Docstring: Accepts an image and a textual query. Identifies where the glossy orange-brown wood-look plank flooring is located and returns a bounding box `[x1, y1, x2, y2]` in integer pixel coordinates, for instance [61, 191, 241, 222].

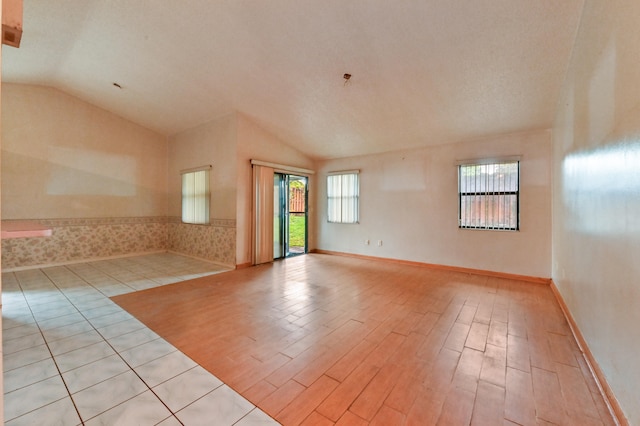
[113, 254, 614, 425]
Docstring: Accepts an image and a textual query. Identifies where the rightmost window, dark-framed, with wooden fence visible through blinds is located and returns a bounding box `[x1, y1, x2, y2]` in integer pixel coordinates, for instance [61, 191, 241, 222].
[458, 161, 520, 231]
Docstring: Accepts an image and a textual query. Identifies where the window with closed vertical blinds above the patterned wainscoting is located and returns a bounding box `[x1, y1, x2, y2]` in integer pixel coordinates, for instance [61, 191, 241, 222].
[182, 166, 211, 224]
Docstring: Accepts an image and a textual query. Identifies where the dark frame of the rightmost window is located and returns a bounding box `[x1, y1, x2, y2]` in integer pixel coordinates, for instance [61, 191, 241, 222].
[457, 157, 521, 232]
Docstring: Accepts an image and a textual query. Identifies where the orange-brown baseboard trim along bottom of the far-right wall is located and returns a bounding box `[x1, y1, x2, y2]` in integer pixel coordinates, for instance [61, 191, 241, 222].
[550, 280, 629, 426]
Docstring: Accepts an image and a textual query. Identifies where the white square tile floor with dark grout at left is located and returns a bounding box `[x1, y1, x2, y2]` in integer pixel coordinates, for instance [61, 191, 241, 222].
[2, 253, 277, 426]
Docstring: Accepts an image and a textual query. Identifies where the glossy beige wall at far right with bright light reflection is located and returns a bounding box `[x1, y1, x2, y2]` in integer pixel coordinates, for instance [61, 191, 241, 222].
[553, 0, 640, 424]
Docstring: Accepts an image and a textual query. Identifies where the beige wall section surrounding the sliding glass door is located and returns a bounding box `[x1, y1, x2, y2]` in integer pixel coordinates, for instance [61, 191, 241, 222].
[236, 114, 315, 265]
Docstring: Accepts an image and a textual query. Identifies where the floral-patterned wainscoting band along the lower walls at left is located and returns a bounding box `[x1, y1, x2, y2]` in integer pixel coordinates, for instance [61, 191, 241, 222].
[2, 220, 236, 270]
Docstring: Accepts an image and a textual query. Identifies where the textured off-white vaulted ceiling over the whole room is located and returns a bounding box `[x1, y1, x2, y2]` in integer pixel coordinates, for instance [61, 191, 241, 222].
[2, 0, 584, 158]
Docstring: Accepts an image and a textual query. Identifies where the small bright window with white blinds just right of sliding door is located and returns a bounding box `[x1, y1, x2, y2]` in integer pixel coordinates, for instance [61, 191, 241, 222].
[327, 171, 360, 223]
